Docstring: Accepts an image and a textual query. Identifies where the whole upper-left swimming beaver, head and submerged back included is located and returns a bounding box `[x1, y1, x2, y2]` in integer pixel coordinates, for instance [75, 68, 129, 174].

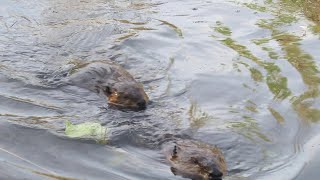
[68, 61, 149, 110]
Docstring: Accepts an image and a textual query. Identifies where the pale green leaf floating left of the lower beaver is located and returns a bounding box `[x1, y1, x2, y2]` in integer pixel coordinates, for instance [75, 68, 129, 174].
[65, 121, 107, 143]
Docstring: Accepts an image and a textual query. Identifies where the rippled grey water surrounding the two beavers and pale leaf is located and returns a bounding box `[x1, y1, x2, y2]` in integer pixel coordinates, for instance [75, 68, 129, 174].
[0, 0, 320, 179]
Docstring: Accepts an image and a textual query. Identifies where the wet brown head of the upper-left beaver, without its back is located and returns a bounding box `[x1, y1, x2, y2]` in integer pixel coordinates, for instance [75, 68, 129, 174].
[104, 81, 149, 109]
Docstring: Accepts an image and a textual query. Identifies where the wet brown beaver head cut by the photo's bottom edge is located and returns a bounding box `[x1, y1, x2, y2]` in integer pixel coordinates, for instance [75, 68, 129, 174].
[165, 140, 227, 180]
